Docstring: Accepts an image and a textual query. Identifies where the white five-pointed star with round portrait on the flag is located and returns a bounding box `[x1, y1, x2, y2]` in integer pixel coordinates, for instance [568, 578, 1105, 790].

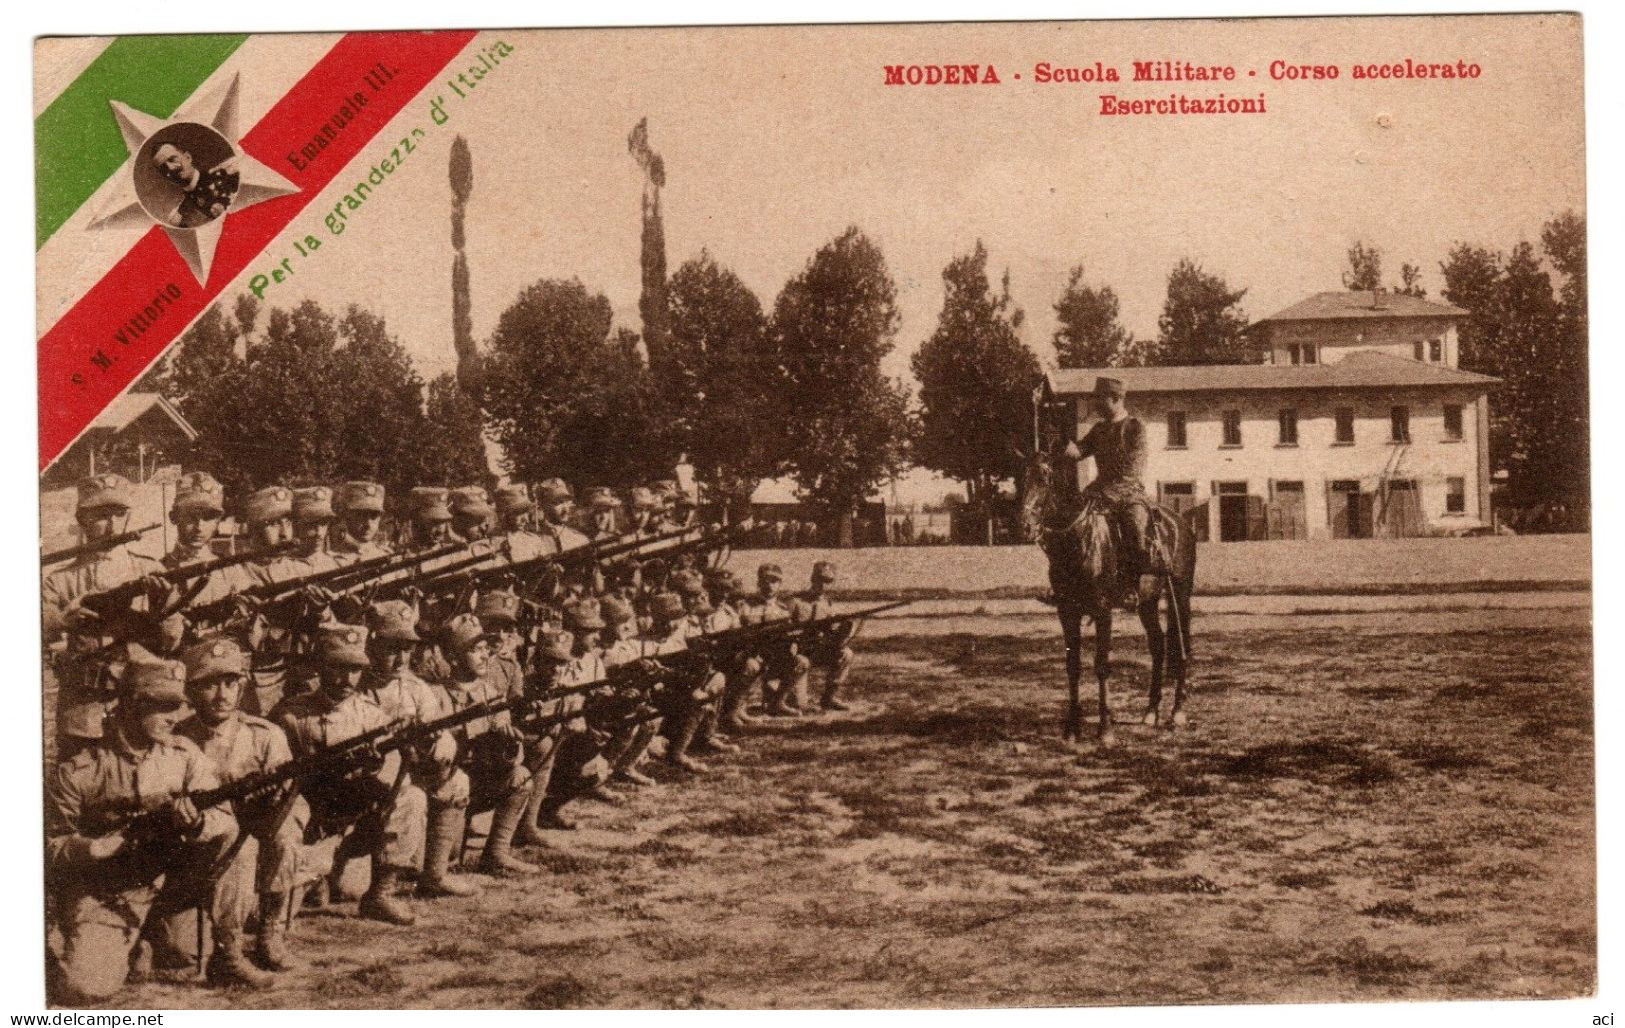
[89, 75, 299, 284]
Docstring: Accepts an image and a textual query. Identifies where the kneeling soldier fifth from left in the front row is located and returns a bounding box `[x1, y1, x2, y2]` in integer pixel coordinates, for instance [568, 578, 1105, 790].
[437, 614, 540, 877]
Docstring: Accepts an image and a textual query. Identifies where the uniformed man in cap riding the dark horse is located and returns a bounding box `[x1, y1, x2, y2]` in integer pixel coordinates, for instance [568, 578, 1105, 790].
[1061, 377, 1152, 578]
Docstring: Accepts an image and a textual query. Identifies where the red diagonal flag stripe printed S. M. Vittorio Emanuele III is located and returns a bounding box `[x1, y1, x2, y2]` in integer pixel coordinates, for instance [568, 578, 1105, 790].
[39, 32, 475, 469]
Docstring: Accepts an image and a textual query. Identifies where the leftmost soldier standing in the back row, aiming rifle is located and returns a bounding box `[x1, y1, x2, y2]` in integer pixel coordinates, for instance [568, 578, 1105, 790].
[41, 474, 164, 757]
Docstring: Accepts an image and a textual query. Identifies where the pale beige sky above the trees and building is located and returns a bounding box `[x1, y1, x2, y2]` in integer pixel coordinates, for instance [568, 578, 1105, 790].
[31, 15, 1584, 500]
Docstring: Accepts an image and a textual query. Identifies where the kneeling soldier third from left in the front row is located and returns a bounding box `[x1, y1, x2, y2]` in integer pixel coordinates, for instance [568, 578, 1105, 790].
[271, 622, 427, 924]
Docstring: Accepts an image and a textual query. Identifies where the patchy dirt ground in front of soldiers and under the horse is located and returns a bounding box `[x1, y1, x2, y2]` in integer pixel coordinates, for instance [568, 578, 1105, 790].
[104, 607, 1596, 1009]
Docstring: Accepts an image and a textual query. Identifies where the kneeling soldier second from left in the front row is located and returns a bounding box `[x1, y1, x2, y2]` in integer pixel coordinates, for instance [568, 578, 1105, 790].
[176, 638, 310, 986]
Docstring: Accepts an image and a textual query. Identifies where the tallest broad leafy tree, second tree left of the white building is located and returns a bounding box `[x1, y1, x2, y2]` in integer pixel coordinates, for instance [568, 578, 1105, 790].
[770, 226, 908, 546]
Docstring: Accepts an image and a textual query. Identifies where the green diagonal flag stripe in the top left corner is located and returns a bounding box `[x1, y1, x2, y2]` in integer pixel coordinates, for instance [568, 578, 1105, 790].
[34, 36, 247, 250]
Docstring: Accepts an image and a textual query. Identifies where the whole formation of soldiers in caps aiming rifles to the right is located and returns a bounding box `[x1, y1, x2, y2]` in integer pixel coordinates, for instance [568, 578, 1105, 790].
[44, 473, 855, 1002]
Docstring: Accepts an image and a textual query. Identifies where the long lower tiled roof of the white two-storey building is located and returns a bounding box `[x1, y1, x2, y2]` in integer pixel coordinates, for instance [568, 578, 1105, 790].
[1045, 349, 1500, 396]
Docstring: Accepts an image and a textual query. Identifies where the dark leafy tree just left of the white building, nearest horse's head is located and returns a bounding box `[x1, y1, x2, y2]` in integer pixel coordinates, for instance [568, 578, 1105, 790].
[912, 239, 1040, 542]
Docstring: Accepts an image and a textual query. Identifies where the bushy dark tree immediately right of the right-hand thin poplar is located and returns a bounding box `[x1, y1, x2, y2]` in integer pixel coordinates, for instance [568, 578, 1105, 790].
[663, 250, 783, 508]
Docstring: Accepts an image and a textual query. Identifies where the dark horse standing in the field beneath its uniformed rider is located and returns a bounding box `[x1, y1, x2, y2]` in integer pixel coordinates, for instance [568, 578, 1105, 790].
[1022, 455, 1196, 747]
